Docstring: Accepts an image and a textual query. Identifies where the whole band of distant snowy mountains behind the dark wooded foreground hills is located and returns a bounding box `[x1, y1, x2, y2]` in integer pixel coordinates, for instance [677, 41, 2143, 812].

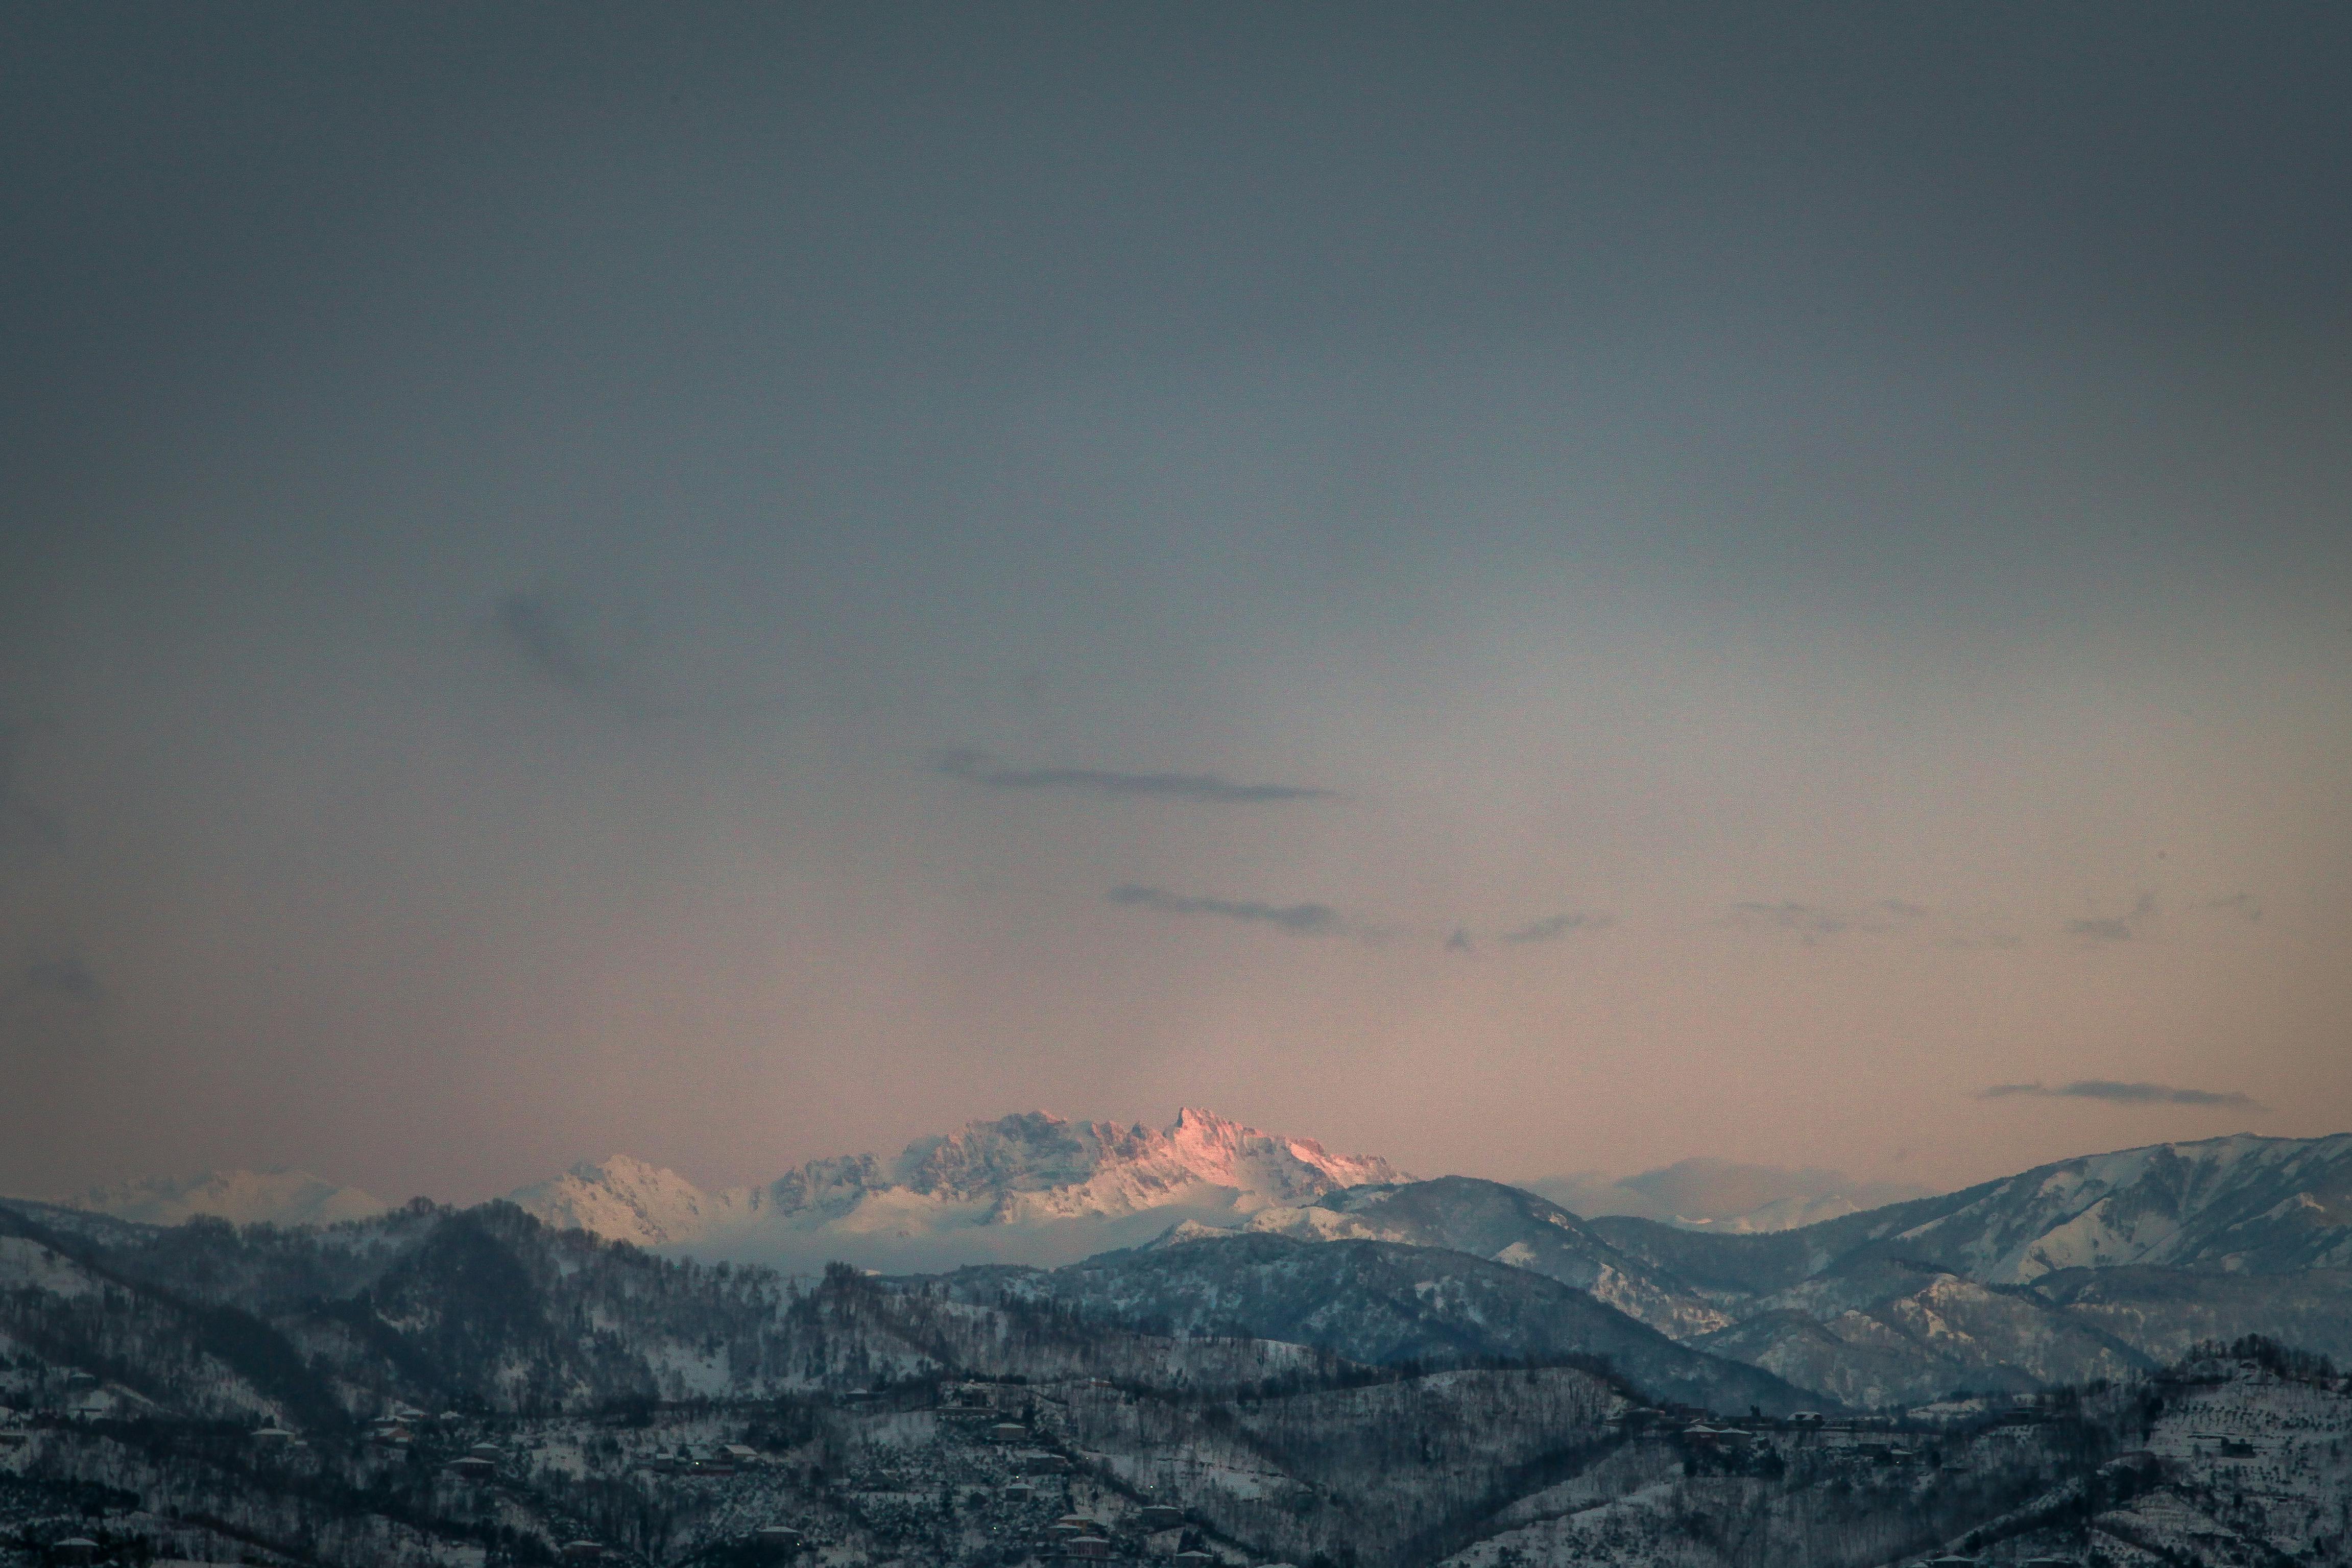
[18, 1109, 2352, 1406]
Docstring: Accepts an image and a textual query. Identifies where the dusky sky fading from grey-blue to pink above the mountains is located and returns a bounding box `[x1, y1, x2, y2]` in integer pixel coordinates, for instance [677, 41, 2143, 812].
[0, 5, 2352, 1201]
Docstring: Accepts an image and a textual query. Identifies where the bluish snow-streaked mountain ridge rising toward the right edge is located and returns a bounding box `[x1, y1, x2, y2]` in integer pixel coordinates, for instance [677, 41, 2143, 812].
[1543, 1136, 2352, 1404]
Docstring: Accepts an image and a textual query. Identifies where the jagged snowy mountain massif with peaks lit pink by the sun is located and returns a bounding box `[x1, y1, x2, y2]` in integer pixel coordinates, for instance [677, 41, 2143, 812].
[513, 1107, 1402, 1269]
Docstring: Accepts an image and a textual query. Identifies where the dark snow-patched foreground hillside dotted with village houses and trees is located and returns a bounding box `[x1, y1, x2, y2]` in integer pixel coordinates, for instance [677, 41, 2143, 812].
[0, 1345, 2352, 1568]
